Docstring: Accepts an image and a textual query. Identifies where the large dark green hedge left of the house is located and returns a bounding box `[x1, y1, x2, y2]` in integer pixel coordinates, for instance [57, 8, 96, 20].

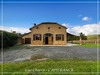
[0, 31, 19, 48]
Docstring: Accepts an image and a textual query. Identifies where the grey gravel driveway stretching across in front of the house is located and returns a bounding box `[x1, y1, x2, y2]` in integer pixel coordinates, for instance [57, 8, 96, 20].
[0, 46, 100, 62]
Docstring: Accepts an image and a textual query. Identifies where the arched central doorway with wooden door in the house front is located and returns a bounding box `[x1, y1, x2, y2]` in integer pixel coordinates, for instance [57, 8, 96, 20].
[43, 33, 53, 45]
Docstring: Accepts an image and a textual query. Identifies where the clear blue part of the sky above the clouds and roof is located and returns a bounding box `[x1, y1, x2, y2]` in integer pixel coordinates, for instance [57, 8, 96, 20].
[3, 3, 97, 28]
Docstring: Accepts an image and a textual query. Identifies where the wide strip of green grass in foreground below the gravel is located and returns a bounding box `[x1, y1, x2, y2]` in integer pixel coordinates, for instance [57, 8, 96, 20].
[0, 59, 100, 75]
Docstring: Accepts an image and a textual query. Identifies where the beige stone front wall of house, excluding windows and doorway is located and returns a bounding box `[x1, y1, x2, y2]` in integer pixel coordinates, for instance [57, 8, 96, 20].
[30, 24, 67, 45]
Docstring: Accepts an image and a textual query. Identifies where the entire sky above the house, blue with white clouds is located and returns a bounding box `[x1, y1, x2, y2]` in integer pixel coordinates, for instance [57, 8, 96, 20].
[0, 0, 100, 35]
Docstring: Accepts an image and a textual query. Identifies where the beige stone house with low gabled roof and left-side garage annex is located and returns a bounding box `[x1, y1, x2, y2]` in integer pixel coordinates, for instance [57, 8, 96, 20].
[22, 22, 67, 45]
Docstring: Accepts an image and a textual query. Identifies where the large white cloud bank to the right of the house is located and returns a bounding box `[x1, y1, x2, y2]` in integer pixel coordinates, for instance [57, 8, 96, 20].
[70, 24, 100, 35]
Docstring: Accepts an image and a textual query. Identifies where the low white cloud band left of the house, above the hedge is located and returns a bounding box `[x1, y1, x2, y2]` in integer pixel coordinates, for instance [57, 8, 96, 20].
[0, 26, 30, 34]
